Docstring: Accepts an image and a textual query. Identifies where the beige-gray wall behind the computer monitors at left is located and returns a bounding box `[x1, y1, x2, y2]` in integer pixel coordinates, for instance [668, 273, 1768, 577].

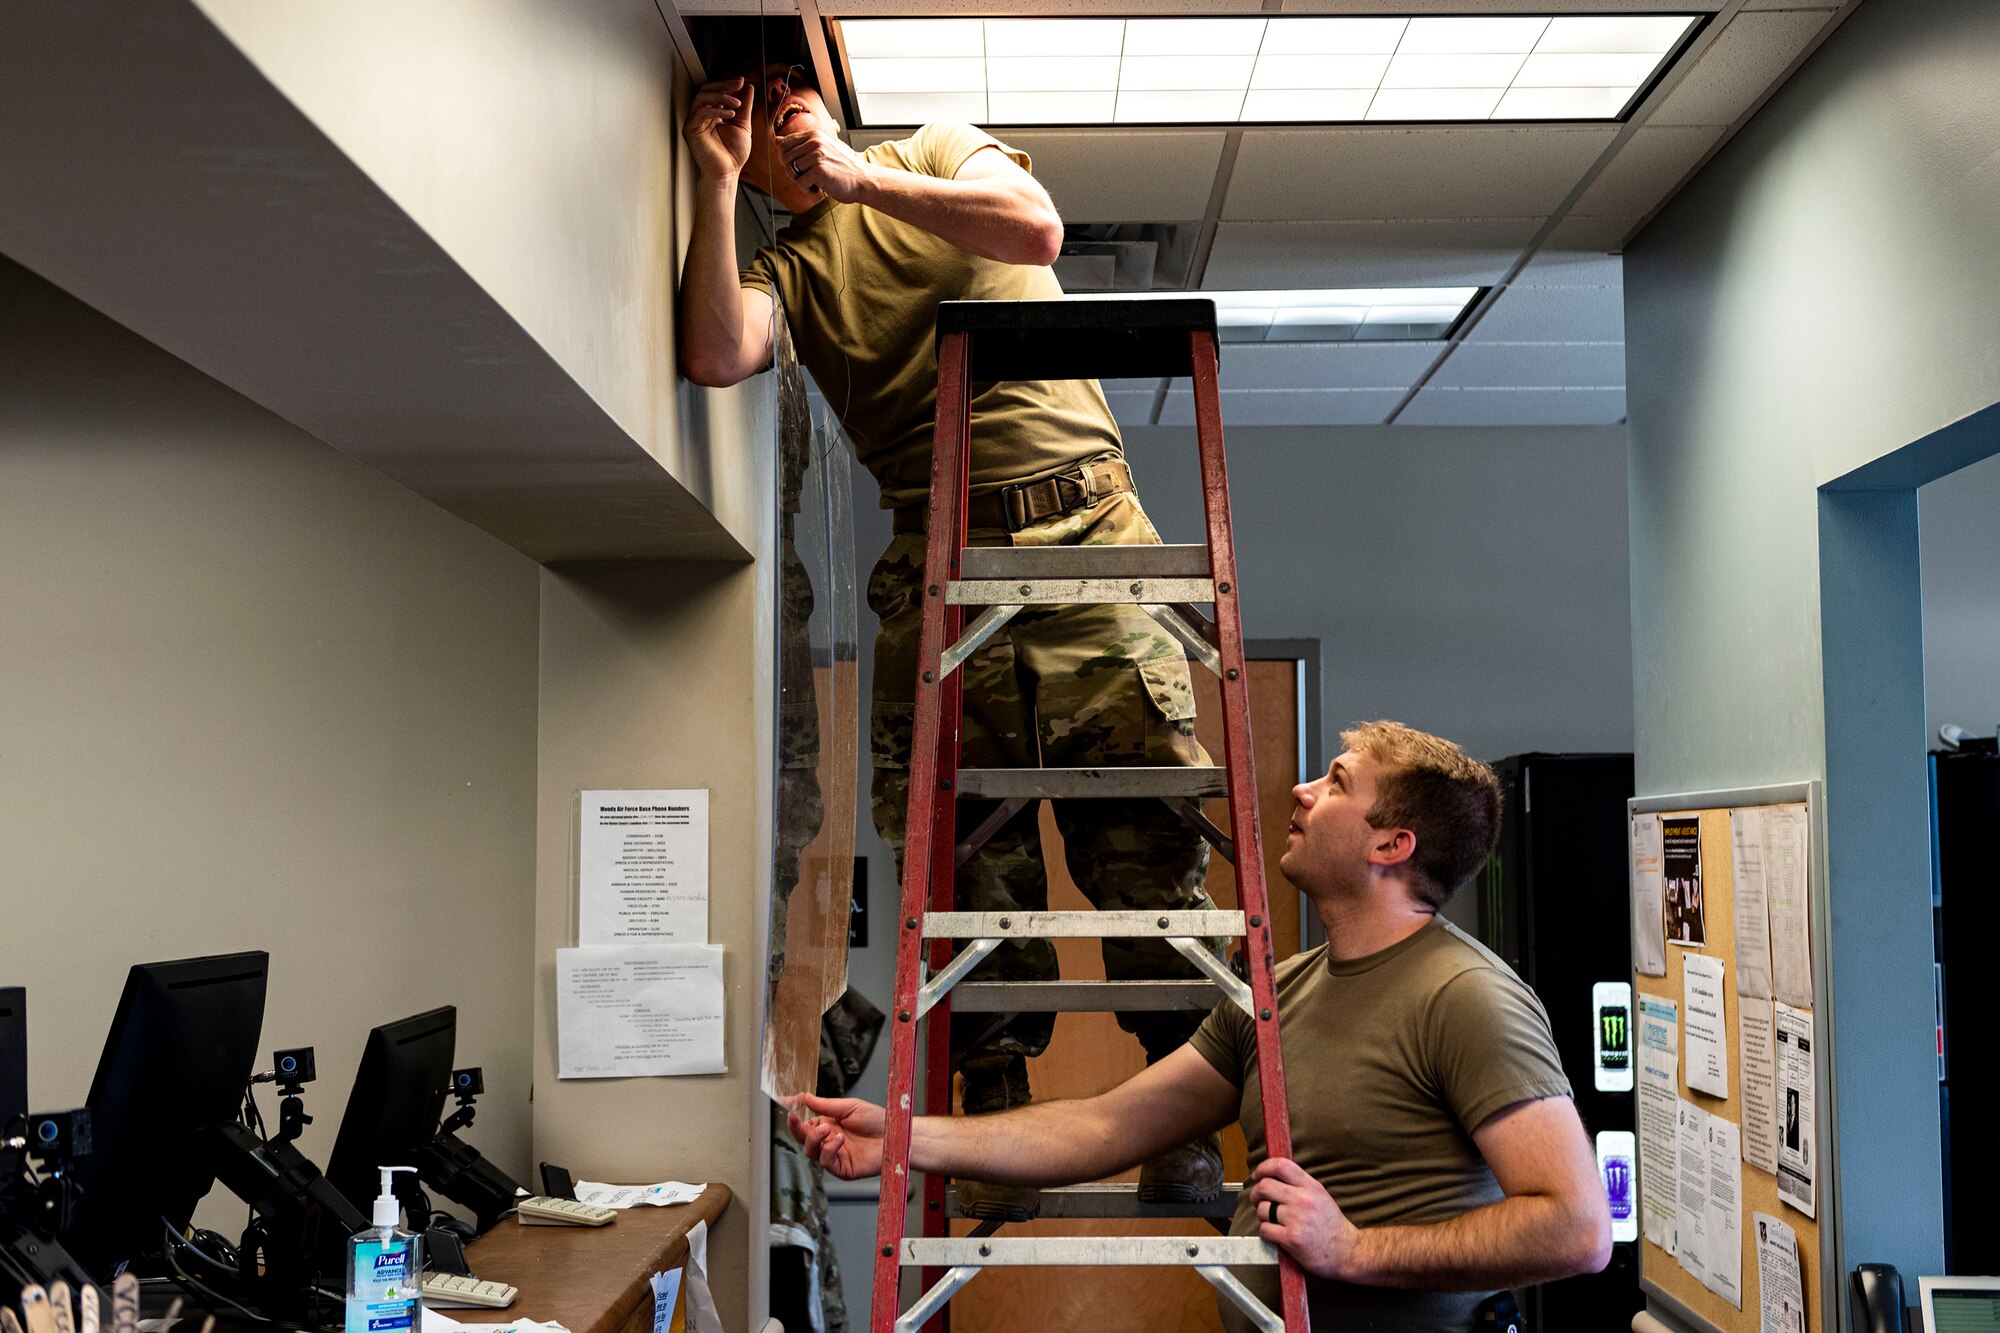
[0, 260, 538, 1208]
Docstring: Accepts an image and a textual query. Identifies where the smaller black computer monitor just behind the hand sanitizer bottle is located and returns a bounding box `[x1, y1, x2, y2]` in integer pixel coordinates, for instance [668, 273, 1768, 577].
[326, 1005, 458, 1223]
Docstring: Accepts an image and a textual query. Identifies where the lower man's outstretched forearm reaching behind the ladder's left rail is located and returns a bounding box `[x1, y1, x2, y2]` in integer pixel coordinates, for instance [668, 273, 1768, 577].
[910, 1099, 1136, 1185]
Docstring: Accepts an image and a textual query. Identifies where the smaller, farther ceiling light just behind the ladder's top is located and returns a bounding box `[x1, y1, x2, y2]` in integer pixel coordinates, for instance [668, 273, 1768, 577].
[1070, 286, 1480, 342]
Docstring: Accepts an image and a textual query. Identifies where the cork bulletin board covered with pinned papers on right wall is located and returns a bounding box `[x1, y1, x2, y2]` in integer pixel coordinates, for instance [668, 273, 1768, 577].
[1630, 783, 1840, 1333]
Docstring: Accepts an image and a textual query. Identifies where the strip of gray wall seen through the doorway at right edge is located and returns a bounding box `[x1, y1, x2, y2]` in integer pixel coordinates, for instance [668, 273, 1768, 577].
[1918, 446, 2000, 747]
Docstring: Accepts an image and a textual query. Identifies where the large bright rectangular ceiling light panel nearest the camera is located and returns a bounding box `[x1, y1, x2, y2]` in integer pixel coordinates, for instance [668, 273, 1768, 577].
[836, 14, 1698, 126]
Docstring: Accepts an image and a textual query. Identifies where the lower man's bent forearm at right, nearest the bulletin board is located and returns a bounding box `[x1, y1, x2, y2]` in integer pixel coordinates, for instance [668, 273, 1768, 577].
[1342, 1195, 1602, 1291]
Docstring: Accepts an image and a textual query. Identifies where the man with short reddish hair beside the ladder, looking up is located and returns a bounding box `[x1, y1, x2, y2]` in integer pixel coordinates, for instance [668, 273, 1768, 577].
[792, 723, 1612, 1333]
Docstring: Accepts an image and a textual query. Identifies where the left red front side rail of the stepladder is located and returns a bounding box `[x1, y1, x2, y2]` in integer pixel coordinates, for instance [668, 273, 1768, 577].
[868, 336, 972, 1333]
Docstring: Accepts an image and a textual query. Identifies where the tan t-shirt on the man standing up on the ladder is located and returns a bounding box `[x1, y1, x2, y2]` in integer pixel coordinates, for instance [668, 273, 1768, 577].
[740, 124, 1120, 508]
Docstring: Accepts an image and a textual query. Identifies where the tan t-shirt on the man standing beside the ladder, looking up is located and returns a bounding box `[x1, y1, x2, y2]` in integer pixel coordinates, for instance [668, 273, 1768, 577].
[1192, 919, 1570, 1333]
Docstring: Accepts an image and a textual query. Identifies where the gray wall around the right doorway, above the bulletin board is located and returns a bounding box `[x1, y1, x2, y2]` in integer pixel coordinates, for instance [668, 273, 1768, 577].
[1626, 0, 2000, 1273]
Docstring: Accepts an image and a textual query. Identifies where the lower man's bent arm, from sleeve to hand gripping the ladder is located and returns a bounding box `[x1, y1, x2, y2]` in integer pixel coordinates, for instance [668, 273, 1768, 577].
[1250, 1097, 1612, 1291]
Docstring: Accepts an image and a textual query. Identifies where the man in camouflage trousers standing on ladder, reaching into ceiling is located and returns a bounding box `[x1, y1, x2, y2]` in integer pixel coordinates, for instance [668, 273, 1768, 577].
[680, 64, 1222, 1221]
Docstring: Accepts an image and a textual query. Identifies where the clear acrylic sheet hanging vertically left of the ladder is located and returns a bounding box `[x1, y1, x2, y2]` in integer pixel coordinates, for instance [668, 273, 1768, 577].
[762, 318, 860, 1097]
